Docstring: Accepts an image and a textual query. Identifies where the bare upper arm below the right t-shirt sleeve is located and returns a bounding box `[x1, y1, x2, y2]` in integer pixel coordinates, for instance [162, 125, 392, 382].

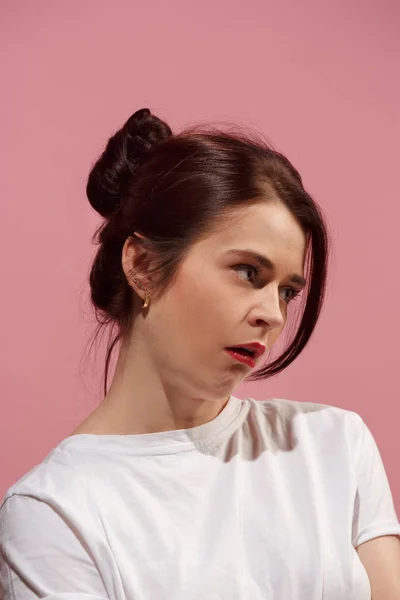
[357, 535, 400, 600]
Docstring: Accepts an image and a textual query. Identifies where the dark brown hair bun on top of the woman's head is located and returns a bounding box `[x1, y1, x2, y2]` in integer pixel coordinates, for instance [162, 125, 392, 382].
[86, 108, 172, 218]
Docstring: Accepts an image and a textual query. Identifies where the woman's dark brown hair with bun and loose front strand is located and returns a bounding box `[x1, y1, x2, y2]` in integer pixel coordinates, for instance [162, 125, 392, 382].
[86, 108, 328, 394]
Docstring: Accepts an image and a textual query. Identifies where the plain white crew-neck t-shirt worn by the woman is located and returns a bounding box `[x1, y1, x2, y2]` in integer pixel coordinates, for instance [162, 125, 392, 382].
[0, 396, 400, 600]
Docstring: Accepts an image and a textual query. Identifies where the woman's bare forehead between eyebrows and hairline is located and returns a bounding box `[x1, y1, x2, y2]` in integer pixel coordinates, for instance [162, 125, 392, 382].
[197, 201, 306, 273]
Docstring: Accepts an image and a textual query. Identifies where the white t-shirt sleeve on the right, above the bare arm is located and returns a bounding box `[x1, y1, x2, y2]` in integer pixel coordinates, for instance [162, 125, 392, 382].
[351, 413, 400, 548]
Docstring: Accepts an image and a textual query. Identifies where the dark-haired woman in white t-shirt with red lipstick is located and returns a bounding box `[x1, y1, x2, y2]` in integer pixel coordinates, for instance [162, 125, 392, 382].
[0, 109, 400, 600]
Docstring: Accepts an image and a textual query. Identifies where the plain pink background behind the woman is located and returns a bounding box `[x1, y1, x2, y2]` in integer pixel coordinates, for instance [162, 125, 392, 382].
[0, 0, 400, 512]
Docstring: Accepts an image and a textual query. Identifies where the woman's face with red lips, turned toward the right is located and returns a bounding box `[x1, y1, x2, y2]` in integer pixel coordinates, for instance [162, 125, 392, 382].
[136, 202, 306, 399]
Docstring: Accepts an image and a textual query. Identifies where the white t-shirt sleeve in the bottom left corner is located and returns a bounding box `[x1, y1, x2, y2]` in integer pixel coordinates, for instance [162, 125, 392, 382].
[0, 495, 108, 600]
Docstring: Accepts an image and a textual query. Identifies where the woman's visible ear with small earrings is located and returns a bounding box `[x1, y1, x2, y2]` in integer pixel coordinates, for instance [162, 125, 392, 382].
[121, 232, 151, 296]
